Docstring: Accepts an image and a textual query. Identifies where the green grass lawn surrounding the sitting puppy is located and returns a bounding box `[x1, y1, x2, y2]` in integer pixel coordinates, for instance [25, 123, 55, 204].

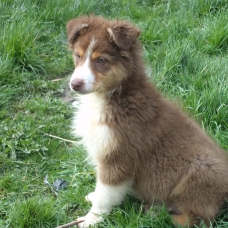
[0, 0, 228, 228]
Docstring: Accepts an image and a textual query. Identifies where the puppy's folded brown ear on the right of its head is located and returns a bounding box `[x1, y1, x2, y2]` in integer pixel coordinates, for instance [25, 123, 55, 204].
[107, 21, 141, 50]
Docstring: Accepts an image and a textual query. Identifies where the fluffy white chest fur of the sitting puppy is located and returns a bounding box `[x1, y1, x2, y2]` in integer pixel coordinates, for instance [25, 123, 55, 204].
[73, 93, 116, 165]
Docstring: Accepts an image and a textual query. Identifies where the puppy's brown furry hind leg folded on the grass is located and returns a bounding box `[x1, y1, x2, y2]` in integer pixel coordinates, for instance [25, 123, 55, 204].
[170, 171, 225, 227]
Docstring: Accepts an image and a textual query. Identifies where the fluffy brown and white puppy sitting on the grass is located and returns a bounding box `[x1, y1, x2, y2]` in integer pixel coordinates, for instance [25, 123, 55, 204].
[67, 15, 228, 227]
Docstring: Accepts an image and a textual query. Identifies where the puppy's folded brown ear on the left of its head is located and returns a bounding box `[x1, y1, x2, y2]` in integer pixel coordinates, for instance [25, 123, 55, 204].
[66, 16, 89, 44]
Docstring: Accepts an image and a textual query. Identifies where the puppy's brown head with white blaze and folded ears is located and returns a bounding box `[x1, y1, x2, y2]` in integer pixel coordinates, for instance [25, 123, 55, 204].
[67, 15, 140, 94]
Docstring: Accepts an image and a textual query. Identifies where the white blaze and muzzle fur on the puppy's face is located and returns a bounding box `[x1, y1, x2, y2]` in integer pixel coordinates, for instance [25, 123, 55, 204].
[70, 38, 96, 93]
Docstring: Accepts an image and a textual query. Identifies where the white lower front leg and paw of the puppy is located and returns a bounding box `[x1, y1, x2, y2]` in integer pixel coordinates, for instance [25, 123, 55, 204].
[78, 180, 131, 228]
